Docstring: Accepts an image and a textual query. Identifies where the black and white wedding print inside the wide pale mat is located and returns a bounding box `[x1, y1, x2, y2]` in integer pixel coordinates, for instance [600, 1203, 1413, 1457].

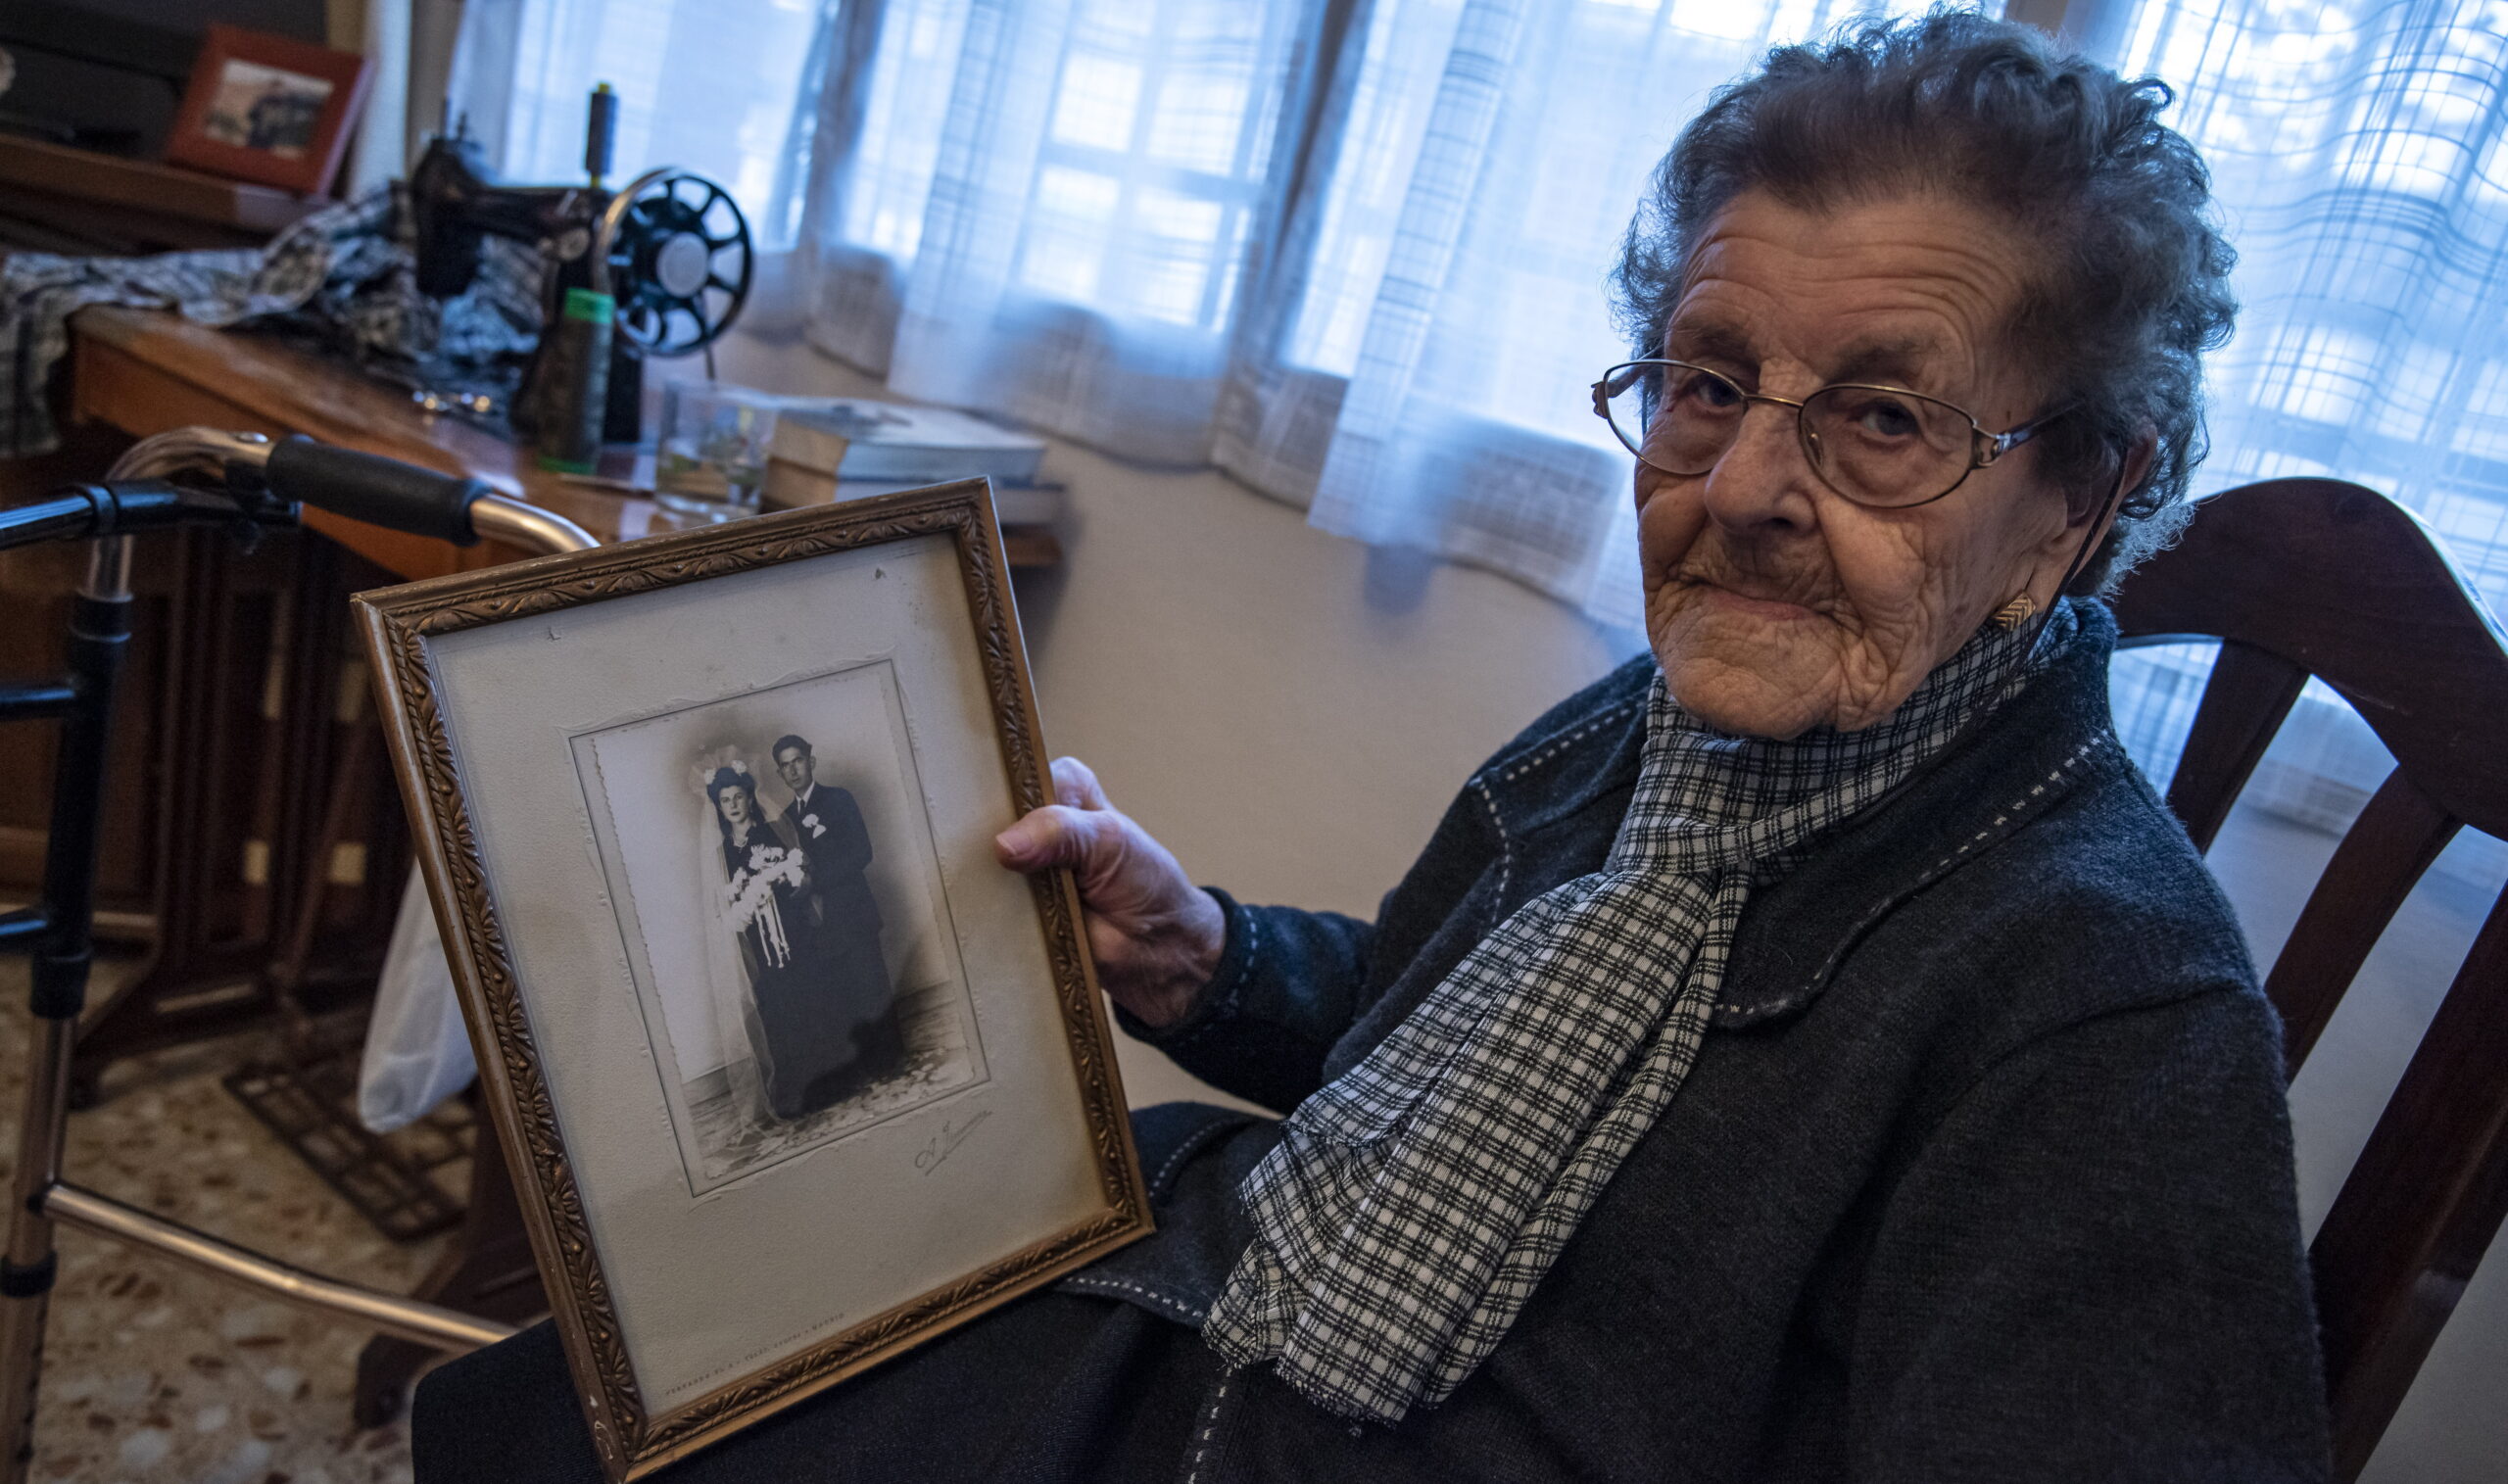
[577, 662, 984, 1193]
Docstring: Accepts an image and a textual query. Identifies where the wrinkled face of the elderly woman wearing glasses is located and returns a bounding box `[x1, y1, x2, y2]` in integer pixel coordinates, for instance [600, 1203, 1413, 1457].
[1638, 193, 2084, 737]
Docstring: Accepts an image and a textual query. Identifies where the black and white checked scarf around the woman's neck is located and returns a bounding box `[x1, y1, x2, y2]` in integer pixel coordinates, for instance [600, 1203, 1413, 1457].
[1201, 604, 2079, 1421]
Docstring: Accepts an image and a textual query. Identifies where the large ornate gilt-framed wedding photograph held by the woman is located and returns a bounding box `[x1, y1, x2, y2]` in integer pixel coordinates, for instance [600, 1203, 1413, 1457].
[357, 479, 1151, 1479]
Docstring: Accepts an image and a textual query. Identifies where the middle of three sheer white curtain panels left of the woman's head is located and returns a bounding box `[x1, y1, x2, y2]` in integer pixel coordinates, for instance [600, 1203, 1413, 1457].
[810, 0, 1322, 466]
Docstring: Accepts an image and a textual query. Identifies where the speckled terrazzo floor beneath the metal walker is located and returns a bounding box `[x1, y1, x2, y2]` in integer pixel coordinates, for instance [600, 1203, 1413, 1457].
[0, 958, 447, 1484]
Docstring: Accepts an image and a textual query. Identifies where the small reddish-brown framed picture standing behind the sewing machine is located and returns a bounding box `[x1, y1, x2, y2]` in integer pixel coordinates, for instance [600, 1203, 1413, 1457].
[166, 25, 371, 196]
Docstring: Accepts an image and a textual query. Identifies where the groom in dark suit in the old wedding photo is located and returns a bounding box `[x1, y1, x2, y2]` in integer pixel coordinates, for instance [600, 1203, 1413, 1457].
[775, 735, 905, 1088]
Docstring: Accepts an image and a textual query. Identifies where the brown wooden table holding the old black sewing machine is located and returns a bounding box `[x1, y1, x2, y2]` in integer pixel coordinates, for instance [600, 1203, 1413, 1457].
[71, 306, 1061, 1426]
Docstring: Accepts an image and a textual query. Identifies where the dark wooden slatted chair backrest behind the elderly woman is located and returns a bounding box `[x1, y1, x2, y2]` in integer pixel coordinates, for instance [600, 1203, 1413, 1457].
[2117, 479, 2508, 1481]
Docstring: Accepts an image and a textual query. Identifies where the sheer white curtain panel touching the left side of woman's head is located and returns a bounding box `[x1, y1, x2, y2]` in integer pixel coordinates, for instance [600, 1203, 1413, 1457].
[1286, 0, 1921, 624]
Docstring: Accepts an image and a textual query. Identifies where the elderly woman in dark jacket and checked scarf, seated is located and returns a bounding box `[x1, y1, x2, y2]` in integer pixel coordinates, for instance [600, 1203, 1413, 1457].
[419, 15, 2328, 1484]
